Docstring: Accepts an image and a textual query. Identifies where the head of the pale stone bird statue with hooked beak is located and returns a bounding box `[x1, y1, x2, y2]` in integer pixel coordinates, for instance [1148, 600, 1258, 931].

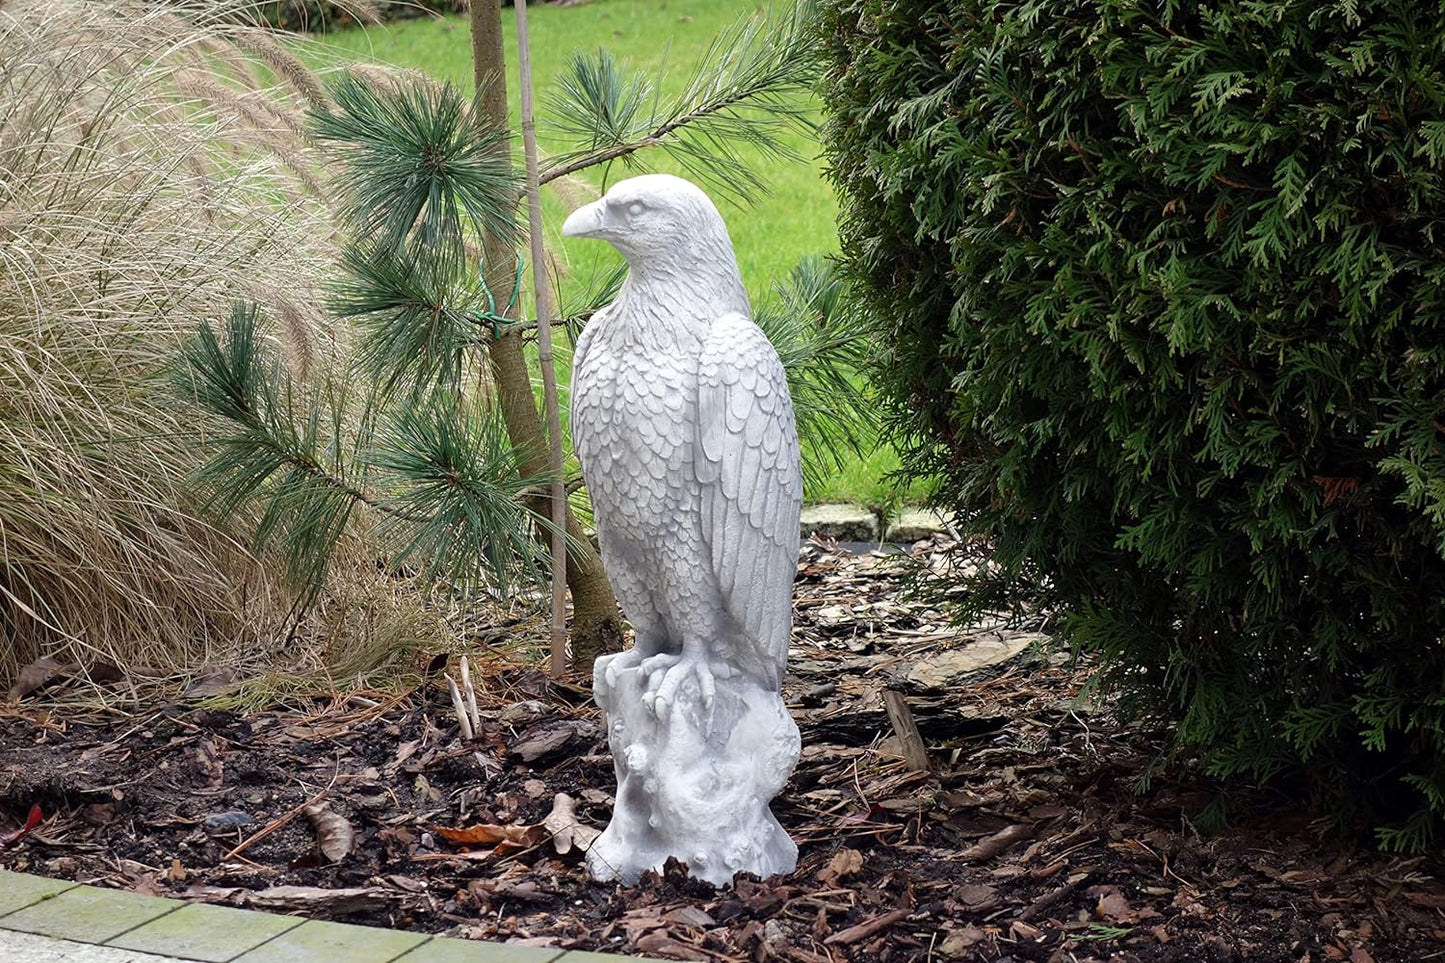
[562, 174, 736, 270]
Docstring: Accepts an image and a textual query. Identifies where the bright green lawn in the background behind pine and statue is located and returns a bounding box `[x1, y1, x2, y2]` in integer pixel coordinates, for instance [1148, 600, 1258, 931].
[309, 0, 916, 503]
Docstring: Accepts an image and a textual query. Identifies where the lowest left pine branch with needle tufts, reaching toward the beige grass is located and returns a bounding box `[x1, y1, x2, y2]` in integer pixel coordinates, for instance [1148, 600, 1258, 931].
[176, 304, 542, 600]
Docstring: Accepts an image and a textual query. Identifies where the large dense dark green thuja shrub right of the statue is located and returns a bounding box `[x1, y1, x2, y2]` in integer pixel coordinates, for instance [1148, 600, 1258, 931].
[821, 0, 1445, 847]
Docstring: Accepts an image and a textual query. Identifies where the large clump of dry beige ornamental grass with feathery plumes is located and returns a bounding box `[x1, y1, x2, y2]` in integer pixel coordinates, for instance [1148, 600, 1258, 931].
[0, 0, 421, 693]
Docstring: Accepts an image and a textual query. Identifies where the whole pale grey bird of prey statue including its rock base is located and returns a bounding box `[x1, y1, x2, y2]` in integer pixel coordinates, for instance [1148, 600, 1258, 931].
[562, 174, 802, 882]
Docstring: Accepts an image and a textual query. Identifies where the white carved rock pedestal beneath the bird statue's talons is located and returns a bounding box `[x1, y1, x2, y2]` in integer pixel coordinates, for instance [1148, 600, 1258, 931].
[587, 656, 801, 885]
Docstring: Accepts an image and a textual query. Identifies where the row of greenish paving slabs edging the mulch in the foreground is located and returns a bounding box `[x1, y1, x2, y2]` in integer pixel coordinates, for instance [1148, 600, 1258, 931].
[0, 869, 637, 963]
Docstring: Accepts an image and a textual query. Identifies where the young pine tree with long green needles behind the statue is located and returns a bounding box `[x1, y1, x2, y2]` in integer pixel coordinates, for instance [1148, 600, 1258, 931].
[174, 0, 861, 672]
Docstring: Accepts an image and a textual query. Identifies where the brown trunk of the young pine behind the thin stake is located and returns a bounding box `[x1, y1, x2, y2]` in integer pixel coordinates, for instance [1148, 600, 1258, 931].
[471, 0, 623, 678]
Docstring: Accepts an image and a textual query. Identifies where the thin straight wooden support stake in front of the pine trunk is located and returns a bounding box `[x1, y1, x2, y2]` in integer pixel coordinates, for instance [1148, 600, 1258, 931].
[514, 0, 566, 677]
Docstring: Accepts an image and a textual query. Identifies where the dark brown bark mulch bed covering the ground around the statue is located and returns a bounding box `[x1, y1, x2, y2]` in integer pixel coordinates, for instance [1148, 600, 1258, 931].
[0, 548, 1445, 963]
